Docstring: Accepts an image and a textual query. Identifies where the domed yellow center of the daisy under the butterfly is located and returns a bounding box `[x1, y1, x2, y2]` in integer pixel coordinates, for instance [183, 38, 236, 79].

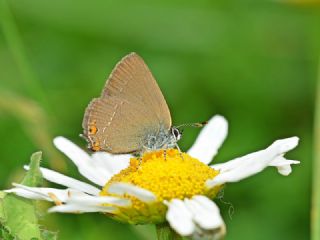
[101, 149, 221, 223]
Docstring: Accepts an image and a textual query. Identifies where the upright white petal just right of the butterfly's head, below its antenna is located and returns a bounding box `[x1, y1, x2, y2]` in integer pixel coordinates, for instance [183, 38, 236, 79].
[188, 115, 228, 164]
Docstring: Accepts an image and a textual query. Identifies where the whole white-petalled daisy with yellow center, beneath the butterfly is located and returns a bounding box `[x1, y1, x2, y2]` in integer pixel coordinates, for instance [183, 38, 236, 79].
[7, 116, 299, 239]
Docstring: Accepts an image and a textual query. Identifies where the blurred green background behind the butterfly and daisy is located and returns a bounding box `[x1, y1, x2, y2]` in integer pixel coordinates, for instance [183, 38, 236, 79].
[0, 0, 320, 240]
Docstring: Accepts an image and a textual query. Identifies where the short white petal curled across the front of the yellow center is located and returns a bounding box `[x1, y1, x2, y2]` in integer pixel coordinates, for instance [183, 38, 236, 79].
[108, 182, 156, 203]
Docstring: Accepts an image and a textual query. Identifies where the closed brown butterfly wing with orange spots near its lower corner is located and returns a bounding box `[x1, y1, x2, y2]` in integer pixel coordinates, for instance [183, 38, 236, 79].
[82, 53, 171, 153]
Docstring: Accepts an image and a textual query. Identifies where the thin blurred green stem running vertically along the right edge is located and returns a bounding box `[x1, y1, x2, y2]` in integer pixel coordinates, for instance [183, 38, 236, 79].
[311, 58, 320, 240]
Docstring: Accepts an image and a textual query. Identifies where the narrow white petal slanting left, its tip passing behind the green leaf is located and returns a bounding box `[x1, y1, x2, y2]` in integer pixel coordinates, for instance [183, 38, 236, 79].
[24, 166, 100, 195]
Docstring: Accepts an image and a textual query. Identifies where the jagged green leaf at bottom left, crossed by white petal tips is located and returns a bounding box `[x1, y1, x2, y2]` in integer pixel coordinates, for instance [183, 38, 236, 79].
[0, 152, 56, 240]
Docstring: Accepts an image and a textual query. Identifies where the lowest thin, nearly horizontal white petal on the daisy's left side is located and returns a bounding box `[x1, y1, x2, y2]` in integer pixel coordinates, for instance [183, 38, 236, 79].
[48, 204, 117, 213]
